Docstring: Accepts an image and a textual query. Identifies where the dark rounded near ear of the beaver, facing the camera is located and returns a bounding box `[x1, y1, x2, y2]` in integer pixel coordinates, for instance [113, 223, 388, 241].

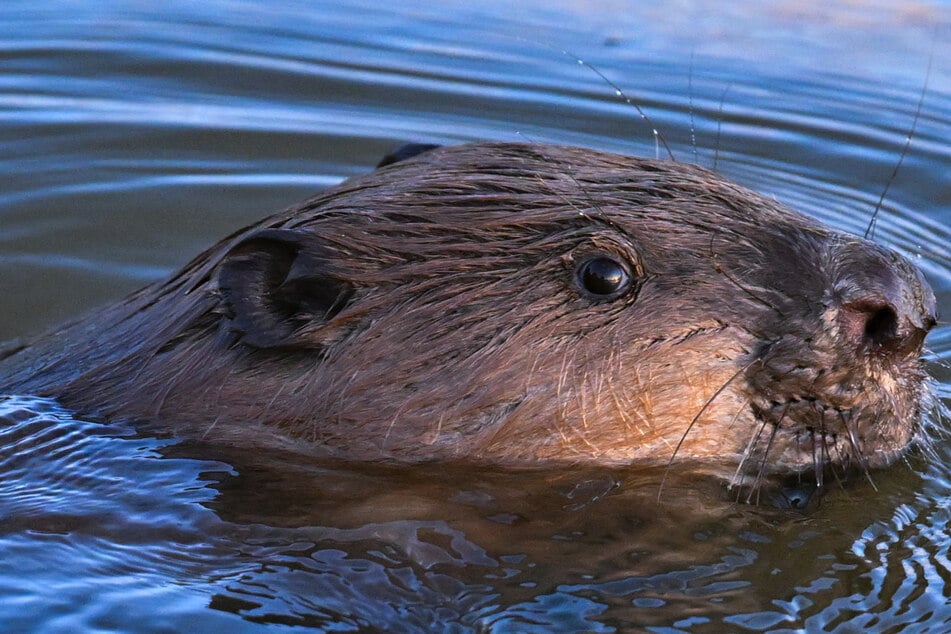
[218, 229, 353, 348]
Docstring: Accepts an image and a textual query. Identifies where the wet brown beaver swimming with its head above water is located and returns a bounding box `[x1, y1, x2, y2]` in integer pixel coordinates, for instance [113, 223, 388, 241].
[0, 143, 936, 484]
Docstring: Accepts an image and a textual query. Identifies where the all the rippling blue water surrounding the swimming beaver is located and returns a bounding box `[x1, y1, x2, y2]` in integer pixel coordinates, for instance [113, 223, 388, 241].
[0, 0, 951, 632]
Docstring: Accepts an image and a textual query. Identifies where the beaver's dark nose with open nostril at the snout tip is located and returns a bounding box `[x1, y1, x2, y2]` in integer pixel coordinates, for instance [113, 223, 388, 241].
[833, 241, 938, 356]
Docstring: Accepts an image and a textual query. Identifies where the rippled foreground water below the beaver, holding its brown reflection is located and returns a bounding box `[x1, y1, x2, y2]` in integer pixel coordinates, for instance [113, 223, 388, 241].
[0, 398, 948, 632]
